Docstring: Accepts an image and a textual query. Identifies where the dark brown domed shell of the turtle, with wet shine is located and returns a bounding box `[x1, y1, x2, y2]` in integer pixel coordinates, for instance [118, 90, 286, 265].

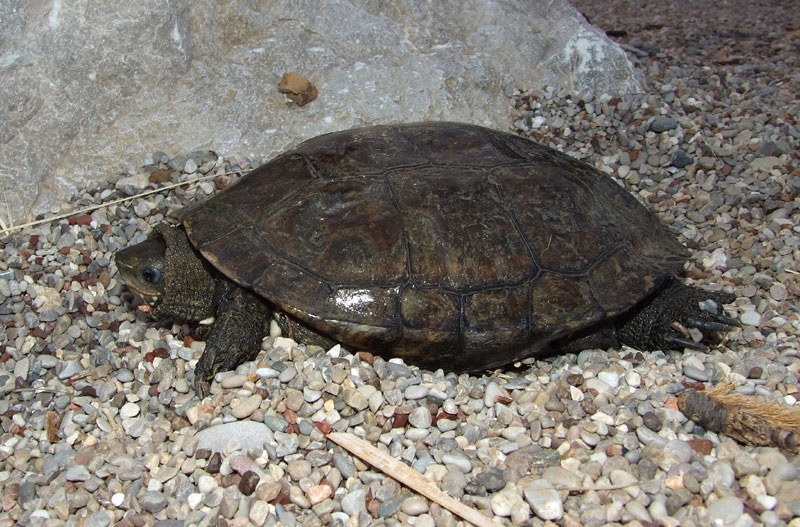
[182, 122, 686, 371]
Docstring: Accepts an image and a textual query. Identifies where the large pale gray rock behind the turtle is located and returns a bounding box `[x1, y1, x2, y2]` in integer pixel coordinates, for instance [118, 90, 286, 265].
[0, 0, 639, 222]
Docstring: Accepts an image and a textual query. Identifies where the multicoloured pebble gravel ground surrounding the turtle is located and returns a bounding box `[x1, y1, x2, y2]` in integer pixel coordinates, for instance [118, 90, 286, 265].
[0, 0, 800, 527]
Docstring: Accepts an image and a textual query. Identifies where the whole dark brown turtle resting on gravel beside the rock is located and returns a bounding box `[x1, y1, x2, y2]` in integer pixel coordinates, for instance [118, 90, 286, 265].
[116, 122, 737, 395]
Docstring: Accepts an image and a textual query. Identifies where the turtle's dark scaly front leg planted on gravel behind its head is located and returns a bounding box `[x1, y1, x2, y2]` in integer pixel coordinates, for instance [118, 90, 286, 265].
[194, 281, 271, 399]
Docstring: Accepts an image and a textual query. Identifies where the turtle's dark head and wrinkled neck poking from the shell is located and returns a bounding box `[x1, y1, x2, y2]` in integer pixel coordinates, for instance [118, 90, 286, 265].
[115, 223, 216, 322]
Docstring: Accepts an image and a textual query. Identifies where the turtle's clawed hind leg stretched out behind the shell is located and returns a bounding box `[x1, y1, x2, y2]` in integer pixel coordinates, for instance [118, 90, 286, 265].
[616, 281, 739, 351]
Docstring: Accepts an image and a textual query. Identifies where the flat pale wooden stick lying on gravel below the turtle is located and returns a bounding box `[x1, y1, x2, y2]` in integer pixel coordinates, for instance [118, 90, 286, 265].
[327, 432, 503, 527]
